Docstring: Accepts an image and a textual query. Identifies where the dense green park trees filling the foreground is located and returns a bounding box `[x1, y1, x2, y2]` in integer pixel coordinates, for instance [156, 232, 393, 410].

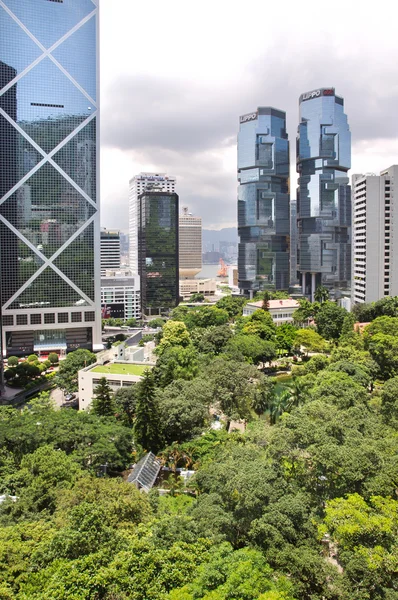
[0, 289, 398, 600]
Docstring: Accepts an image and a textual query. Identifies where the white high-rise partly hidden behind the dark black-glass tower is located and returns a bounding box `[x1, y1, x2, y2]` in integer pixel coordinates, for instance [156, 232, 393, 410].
[129, 173, 176, 273]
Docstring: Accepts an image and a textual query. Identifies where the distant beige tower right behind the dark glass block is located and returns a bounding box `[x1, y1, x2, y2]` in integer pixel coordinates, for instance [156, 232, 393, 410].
[179, 206, 202, 279]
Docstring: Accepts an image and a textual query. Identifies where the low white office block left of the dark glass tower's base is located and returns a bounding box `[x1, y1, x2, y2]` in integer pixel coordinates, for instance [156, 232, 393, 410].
[101, 269, 141, 319]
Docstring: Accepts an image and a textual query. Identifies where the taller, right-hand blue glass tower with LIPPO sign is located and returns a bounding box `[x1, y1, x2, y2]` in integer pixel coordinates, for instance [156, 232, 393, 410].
[297, 88, 351, 299]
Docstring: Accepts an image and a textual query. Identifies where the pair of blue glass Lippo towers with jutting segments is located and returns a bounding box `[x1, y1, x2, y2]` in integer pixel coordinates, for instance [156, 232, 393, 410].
[238, 88, 351, 299]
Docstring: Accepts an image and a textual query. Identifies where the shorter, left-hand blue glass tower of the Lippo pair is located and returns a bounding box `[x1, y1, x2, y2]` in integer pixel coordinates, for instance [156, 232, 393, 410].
[238, 107, 290, 296]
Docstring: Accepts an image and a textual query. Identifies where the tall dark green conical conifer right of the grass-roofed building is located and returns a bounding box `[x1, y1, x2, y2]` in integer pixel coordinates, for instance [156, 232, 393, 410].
[134, 370, 163, 454]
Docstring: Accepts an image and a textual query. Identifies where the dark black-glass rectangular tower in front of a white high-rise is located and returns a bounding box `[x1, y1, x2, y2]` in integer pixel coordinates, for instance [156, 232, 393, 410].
[138, 192, 179, 315]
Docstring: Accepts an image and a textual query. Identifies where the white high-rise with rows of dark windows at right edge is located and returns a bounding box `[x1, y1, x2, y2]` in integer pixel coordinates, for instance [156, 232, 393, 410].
[351, 165, 398, 304]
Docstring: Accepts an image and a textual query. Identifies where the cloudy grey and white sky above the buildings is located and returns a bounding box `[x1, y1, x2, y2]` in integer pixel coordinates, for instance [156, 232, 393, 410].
[100, 0, 398, 231]
